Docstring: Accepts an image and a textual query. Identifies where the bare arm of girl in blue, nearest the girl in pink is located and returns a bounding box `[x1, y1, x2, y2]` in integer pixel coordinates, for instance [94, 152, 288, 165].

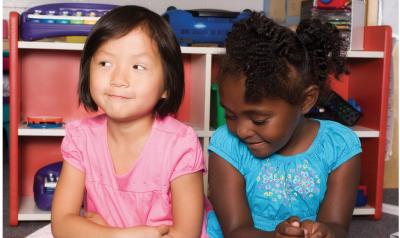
[208, 153, 274, 238]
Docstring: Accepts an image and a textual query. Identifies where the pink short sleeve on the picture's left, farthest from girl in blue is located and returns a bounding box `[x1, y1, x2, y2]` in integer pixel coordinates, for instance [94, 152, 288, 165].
[61, 124, 85, 172]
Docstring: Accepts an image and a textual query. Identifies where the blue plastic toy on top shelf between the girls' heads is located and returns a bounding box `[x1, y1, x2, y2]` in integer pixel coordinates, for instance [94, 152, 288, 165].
[163, 7, 249, 46]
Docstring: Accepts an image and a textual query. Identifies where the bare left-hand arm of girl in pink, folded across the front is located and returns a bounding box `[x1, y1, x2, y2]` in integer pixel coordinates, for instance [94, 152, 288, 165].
[51, 162, 168, 238]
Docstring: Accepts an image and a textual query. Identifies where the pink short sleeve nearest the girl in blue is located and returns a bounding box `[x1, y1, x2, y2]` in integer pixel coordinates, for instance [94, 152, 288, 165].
[171, 128, 205, 181]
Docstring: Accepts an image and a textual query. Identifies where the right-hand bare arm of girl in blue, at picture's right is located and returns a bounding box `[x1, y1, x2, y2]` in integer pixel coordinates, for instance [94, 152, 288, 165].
[317, 155, 361, 237]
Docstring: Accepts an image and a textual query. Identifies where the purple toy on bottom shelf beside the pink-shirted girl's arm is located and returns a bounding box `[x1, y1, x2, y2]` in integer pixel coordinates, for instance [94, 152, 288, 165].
[33, 161, 62, 211]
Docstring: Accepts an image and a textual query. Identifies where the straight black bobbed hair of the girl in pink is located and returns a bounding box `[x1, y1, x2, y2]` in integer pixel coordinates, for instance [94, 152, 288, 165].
[78, 6, 185, 118]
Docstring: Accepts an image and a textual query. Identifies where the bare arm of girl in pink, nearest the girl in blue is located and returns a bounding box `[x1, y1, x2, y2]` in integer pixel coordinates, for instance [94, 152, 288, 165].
[168, 171, 204, 238]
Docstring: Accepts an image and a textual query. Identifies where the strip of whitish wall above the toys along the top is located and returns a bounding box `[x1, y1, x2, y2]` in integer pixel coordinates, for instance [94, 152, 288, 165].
[3, 0, 264, 19]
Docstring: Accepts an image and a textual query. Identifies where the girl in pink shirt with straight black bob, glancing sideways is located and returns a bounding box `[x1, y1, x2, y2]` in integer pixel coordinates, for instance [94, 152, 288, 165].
[52, 6, 207, 238]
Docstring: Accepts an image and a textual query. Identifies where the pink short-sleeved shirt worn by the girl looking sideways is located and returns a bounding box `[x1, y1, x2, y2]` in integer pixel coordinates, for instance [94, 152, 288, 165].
[61, 115, 209, 236]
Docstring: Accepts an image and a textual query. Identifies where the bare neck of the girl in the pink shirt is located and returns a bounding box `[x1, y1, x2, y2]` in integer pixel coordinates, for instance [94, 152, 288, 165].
[107, 115, 155, 143]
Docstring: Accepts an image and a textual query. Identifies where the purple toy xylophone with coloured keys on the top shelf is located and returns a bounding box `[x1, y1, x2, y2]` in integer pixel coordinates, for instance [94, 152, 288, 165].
[21, 3, 116, 41]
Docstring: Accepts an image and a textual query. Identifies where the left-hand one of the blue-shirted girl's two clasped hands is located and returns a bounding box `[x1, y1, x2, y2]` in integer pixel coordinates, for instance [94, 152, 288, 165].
[274, 216, 307, 238]
